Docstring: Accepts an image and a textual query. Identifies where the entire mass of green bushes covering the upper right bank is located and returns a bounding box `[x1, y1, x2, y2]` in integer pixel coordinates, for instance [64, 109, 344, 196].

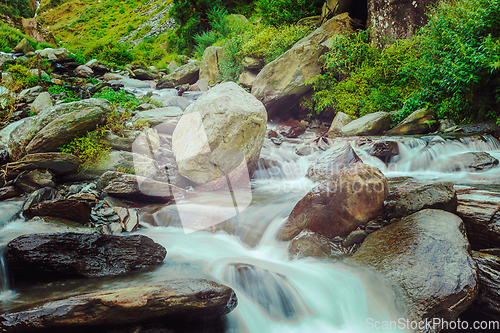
[309, 0, 500, 121]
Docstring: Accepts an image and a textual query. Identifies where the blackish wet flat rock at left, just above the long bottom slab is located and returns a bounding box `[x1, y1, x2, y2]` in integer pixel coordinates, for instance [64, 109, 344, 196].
[5, 233, 167, 284]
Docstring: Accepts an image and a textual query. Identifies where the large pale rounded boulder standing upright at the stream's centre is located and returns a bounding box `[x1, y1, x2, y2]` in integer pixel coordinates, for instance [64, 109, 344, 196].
[172, 82, 267, 185]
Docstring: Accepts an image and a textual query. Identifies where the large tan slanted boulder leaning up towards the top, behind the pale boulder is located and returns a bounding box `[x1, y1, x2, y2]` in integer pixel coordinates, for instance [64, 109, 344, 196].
[252, 13, 352, 119]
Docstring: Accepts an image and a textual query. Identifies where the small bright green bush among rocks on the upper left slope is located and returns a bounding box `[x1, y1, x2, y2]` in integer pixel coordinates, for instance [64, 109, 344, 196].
[83, 41, 134, 66]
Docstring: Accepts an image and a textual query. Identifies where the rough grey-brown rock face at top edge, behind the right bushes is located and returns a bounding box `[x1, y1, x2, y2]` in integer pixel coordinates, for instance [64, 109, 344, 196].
[367, 0, 438, 44]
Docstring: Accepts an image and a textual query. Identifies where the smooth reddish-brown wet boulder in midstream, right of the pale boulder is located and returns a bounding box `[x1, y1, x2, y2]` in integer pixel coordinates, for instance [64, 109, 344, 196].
[278, 163, 389, 241]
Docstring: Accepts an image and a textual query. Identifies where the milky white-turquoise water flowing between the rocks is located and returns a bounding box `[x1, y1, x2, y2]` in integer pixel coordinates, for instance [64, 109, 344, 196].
[0, 134, 500, 332]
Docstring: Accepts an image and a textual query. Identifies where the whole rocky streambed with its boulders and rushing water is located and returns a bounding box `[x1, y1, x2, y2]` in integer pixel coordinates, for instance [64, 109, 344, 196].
[0, 48, 500, 332]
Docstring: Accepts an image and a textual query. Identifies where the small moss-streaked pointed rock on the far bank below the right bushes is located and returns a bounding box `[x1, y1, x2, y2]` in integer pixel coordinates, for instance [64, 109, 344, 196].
[387, 109, 437, 135]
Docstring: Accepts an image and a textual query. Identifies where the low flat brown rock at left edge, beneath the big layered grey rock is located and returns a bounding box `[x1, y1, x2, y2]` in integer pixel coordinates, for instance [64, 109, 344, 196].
[7, 153, 80, 178]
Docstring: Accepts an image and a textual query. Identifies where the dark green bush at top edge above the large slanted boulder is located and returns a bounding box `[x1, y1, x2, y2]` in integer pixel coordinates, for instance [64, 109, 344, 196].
[255, 0, 324, 26]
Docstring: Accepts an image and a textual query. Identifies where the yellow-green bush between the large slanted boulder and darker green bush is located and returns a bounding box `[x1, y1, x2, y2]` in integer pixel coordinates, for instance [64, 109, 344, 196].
[308, 31, 419, 118]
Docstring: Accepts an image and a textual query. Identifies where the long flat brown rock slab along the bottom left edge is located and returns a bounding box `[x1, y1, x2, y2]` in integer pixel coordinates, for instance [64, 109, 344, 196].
[0, 279, 237, 333]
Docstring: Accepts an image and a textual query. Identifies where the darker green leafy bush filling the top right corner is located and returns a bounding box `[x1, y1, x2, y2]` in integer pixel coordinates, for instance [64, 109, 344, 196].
[398, 0, 500, 121]
